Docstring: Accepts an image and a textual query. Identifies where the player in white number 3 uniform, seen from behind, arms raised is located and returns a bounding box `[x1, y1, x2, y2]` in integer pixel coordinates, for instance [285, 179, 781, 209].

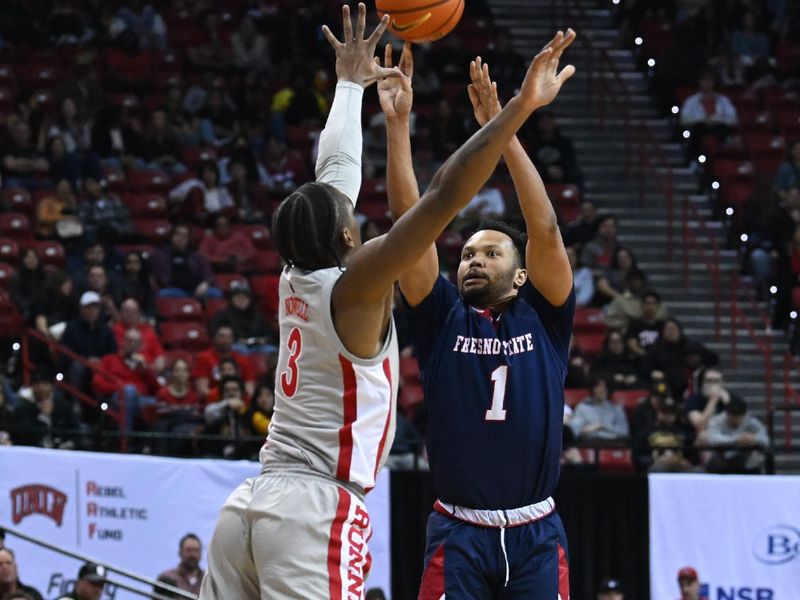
[200, 4, 576, 600]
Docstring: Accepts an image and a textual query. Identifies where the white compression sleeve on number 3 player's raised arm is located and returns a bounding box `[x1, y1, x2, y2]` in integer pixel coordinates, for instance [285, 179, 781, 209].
[315, 81, 364, 207]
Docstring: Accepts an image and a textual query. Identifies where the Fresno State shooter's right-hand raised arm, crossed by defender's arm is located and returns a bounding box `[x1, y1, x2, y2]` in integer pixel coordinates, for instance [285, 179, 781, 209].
[468, 43, 575, 306]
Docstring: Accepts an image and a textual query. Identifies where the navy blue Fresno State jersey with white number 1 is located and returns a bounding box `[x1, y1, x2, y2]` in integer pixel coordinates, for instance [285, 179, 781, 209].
[410, 276, 575, 510]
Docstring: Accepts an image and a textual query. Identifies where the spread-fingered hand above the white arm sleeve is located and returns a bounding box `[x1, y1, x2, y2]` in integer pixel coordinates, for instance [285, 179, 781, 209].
[322, 2, 398, 87]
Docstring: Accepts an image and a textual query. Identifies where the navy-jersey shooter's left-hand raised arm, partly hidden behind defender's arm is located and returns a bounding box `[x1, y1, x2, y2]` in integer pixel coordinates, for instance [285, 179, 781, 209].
[378, 42, 439, 306]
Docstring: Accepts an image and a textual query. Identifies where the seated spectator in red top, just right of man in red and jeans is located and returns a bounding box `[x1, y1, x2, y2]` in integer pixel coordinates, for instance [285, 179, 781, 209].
[152, 358, 204, 456]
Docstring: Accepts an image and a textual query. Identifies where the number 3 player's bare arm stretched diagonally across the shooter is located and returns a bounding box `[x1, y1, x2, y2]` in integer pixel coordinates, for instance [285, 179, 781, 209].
[337, 32, 575, 304]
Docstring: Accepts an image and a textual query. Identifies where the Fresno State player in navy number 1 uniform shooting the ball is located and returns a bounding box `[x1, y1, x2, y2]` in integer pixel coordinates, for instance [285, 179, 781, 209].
[378, 30, 575, 600]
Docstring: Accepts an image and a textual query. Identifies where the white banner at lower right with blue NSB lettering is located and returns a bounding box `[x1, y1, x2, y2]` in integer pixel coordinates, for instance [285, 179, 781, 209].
[649, 474, 800, 600]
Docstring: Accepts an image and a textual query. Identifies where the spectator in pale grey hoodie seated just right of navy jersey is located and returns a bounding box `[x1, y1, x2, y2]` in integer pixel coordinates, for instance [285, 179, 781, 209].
[569, 374, 628, 441]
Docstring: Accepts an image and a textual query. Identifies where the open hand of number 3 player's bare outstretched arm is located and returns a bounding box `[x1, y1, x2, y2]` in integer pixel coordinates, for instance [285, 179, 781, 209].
[519, 29, 575, 111]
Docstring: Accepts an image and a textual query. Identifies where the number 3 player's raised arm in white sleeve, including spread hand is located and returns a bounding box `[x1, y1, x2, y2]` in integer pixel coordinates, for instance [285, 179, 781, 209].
[315, 3, 396, 206]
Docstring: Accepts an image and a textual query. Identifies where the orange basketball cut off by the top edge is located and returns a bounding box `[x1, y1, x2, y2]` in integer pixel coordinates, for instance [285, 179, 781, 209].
[375, 0, 464, 42]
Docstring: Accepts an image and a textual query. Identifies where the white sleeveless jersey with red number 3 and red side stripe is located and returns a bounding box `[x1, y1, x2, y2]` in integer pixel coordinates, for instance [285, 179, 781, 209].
[260, 268, 398, 490]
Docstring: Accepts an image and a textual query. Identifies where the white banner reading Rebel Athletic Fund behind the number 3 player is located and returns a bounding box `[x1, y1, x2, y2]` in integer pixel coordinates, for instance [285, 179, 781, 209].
[0, 447, 391, 600]
